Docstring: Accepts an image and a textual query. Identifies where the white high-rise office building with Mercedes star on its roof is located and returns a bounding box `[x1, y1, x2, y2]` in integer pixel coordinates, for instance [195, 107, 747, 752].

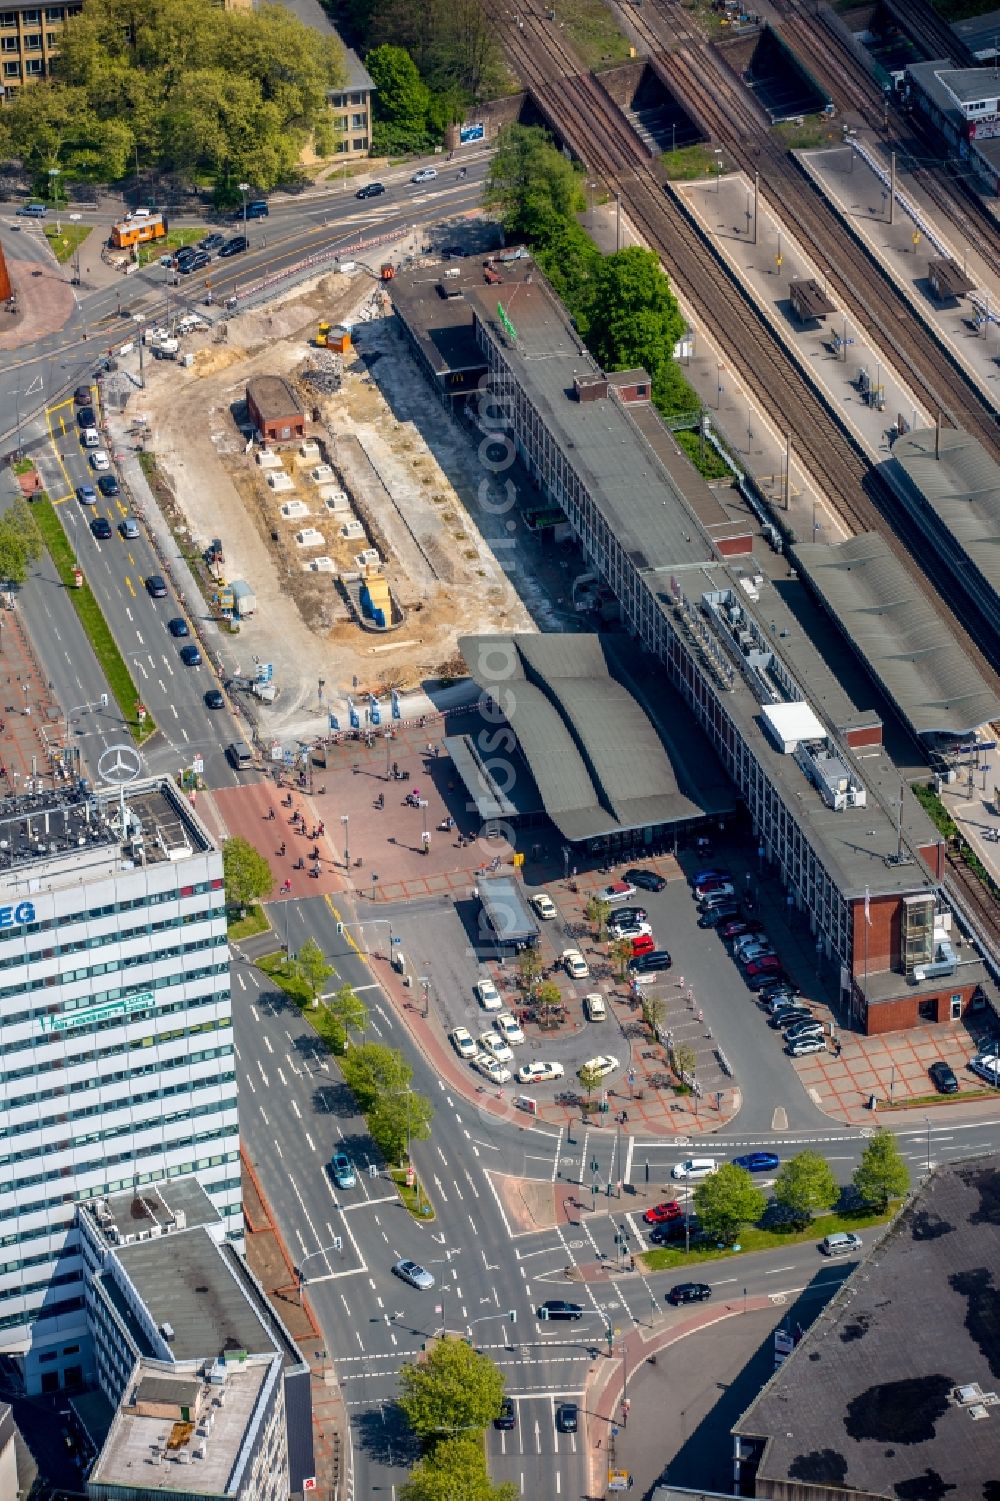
[0, 774, 243, 1391]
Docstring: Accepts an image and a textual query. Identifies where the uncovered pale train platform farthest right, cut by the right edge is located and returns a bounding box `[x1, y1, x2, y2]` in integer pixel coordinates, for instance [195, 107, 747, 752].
[799, 143, 1000, 404]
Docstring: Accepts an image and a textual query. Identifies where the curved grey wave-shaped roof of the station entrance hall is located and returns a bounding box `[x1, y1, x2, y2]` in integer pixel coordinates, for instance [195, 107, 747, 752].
[459, 635, 694, 842]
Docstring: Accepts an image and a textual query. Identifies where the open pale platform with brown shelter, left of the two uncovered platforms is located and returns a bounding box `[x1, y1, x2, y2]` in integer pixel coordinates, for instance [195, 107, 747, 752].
[677, 173, 931, 465]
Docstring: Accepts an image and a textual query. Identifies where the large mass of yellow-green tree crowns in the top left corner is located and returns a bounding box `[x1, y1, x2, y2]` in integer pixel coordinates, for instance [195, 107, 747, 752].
[0, 0, 345, 192]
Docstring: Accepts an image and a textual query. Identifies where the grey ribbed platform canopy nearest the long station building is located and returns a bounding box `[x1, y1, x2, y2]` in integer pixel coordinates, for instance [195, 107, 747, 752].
[796, 531, 1000, 735]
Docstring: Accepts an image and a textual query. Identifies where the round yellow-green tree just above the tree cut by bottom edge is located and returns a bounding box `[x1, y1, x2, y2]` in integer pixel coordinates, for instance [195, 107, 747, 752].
[399, 1339, 505, 1440]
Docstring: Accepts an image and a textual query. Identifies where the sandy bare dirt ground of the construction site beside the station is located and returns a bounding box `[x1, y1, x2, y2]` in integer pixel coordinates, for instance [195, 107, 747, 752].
[141, 273, 532, 732]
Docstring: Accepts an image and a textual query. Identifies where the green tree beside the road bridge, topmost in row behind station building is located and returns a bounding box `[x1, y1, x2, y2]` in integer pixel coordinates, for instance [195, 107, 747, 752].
[483, 125, 587, 242]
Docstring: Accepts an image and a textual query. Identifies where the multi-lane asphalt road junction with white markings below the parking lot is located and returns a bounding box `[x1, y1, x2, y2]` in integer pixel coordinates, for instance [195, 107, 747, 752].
[233, 899, 1000, 1496]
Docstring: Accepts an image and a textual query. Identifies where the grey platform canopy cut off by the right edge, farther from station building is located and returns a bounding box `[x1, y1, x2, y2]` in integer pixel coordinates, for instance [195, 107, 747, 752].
[892, 428, 1000, 594]
